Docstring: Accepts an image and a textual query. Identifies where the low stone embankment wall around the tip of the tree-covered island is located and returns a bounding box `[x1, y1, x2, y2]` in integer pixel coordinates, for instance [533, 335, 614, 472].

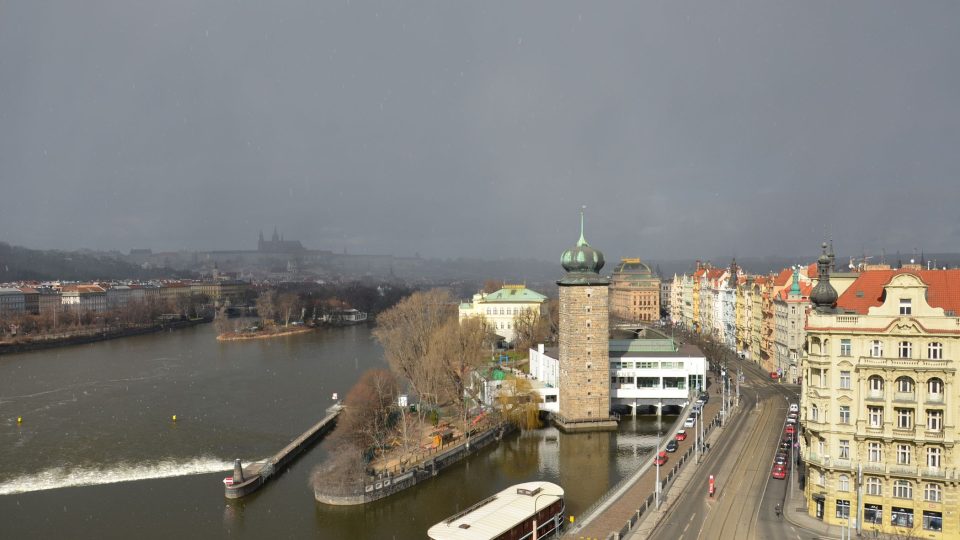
[314, 424, 517, 506]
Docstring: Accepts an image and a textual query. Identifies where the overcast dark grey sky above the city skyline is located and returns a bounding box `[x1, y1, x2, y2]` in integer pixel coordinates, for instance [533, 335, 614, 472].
[0, 0, 960, 260]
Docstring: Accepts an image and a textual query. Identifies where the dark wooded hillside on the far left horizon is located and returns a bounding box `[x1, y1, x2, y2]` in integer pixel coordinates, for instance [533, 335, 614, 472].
[0, 242, 190, 283]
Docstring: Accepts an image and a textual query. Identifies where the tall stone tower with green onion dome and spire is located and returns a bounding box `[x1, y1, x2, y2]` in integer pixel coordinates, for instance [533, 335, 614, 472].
[556, 209, 617, 431]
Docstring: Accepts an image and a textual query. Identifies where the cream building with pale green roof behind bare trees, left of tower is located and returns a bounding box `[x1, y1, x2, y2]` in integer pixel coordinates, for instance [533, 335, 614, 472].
[459, 285, 547, 343]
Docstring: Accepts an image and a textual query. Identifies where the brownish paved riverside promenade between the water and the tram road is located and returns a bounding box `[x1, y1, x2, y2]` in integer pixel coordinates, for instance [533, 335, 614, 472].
[564, 376, 721, 540]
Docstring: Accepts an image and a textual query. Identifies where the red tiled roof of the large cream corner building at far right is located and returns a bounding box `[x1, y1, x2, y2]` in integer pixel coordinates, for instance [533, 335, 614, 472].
[837, 269, 960, 314]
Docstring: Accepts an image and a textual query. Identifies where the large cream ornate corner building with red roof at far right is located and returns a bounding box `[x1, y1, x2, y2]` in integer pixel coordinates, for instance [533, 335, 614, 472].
[800, 252, 960, 538]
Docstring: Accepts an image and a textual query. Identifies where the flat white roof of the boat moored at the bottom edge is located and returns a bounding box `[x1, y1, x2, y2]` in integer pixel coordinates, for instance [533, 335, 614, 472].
[427, 482, 563, 540]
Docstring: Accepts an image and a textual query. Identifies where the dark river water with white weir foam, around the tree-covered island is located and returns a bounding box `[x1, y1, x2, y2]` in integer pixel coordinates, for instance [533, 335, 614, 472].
[0, 325, 673, 540]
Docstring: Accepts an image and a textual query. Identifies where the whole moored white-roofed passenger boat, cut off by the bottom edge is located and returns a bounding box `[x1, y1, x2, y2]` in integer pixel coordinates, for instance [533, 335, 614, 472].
[427, 482, 566, 540]
